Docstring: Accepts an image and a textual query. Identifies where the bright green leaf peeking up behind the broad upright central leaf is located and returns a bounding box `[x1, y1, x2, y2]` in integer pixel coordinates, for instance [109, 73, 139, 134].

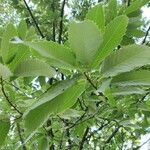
[86, 4, 105, 32]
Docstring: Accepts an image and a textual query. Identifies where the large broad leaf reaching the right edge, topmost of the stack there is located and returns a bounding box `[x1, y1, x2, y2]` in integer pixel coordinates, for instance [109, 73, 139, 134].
[101, 45, 150, 77]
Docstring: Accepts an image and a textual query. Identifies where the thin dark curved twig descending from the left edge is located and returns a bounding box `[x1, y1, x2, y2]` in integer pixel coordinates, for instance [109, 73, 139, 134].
[1, 77, 23, 116]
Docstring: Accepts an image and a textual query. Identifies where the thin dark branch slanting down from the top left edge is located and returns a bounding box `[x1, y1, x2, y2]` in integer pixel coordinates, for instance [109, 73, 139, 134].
[23, 0, 44, 38]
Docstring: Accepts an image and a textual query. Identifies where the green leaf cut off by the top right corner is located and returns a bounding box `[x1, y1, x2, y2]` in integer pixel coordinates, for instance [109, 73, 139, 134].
[125, 0, 149, 14]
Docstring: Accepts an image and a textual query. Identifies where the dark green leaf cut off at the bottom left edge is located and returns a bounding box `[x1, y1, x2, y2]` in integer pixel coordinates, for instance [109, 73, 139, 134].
[0, 120, 10, 147]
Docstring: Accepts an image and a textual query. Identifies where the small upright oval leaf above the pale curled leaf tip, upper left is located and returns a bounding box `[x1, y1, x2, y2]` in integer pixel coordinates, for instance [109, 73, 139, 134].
[18, 20, 27, 39]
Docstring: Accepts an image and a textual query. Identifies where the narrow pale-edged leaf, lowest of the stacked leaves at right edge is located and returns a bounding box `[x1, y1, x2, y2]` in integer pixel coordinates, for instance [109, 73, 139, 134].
[111, 86, 146, 96]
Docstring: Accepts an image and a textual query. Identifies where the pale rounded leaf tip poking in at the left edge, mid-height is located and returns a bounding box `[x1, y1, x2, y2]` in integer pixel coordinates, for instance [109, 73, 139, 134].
[0, 63, 12, 79]
